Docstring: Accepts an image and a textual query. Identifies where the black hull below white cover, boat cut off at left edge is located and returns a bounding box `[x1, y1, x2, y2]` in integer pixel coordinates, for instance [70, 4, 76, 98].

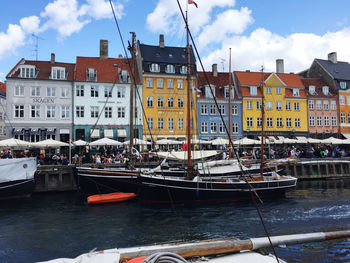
[0, 179, 35, 200]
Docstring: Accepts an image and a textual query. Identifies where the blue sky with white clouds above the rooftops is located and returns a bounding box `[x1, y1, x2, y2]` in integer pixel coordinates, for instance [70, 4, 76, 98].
[0, 0, 350, 81]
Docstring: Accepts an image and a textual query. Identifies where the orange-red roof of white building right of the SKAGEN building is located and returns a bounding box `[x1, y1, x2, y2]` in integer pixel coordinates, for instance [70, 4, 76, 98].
[75, 57, 140, 84]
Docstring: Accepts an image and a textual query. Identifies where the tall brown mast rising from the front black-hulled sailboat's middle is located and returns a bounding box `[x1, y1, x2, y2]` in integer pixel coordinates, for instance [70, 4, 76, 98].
[186, 10, 192, 179]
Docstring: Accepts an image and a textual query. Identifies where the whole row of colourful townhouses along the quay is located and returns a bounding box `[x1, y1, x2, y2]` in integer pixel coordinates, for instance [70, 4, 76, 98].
[0, 35, 350, 142]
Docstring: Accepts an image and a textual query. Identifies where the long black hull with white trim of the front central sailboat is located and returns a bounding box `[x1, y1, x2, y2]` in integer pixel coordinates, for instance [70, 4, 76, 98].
[139, 175, 296, 203]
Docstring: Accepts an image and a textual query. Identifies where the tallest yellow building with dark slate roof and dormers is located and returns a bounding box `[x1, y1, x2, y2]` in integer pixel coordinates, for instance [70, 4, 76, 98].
[139, 35, 197, 140]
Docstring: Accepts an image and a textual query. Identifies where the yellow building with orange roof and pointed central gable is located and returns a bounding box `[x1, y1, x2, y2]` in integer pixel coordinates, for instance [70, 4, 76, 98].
[235, 72, 308, 138]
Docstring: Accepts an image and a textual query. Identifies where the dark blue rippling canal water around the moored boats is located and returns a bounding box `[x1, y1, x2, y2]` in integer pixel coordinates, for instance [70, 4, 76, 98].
[0, 179, 350, 263]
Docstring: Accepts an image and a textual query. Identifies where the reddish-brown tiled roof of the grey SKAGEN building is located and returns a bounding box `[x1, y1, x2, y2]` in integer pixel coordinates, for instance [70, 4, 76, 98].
[7, 60, 75, 81]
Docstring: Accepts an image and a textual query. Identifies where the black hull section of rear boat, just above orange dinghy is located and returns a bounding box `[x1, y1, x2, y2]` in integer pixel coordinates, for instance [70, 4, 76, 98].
[75, 168, 140, 195]
